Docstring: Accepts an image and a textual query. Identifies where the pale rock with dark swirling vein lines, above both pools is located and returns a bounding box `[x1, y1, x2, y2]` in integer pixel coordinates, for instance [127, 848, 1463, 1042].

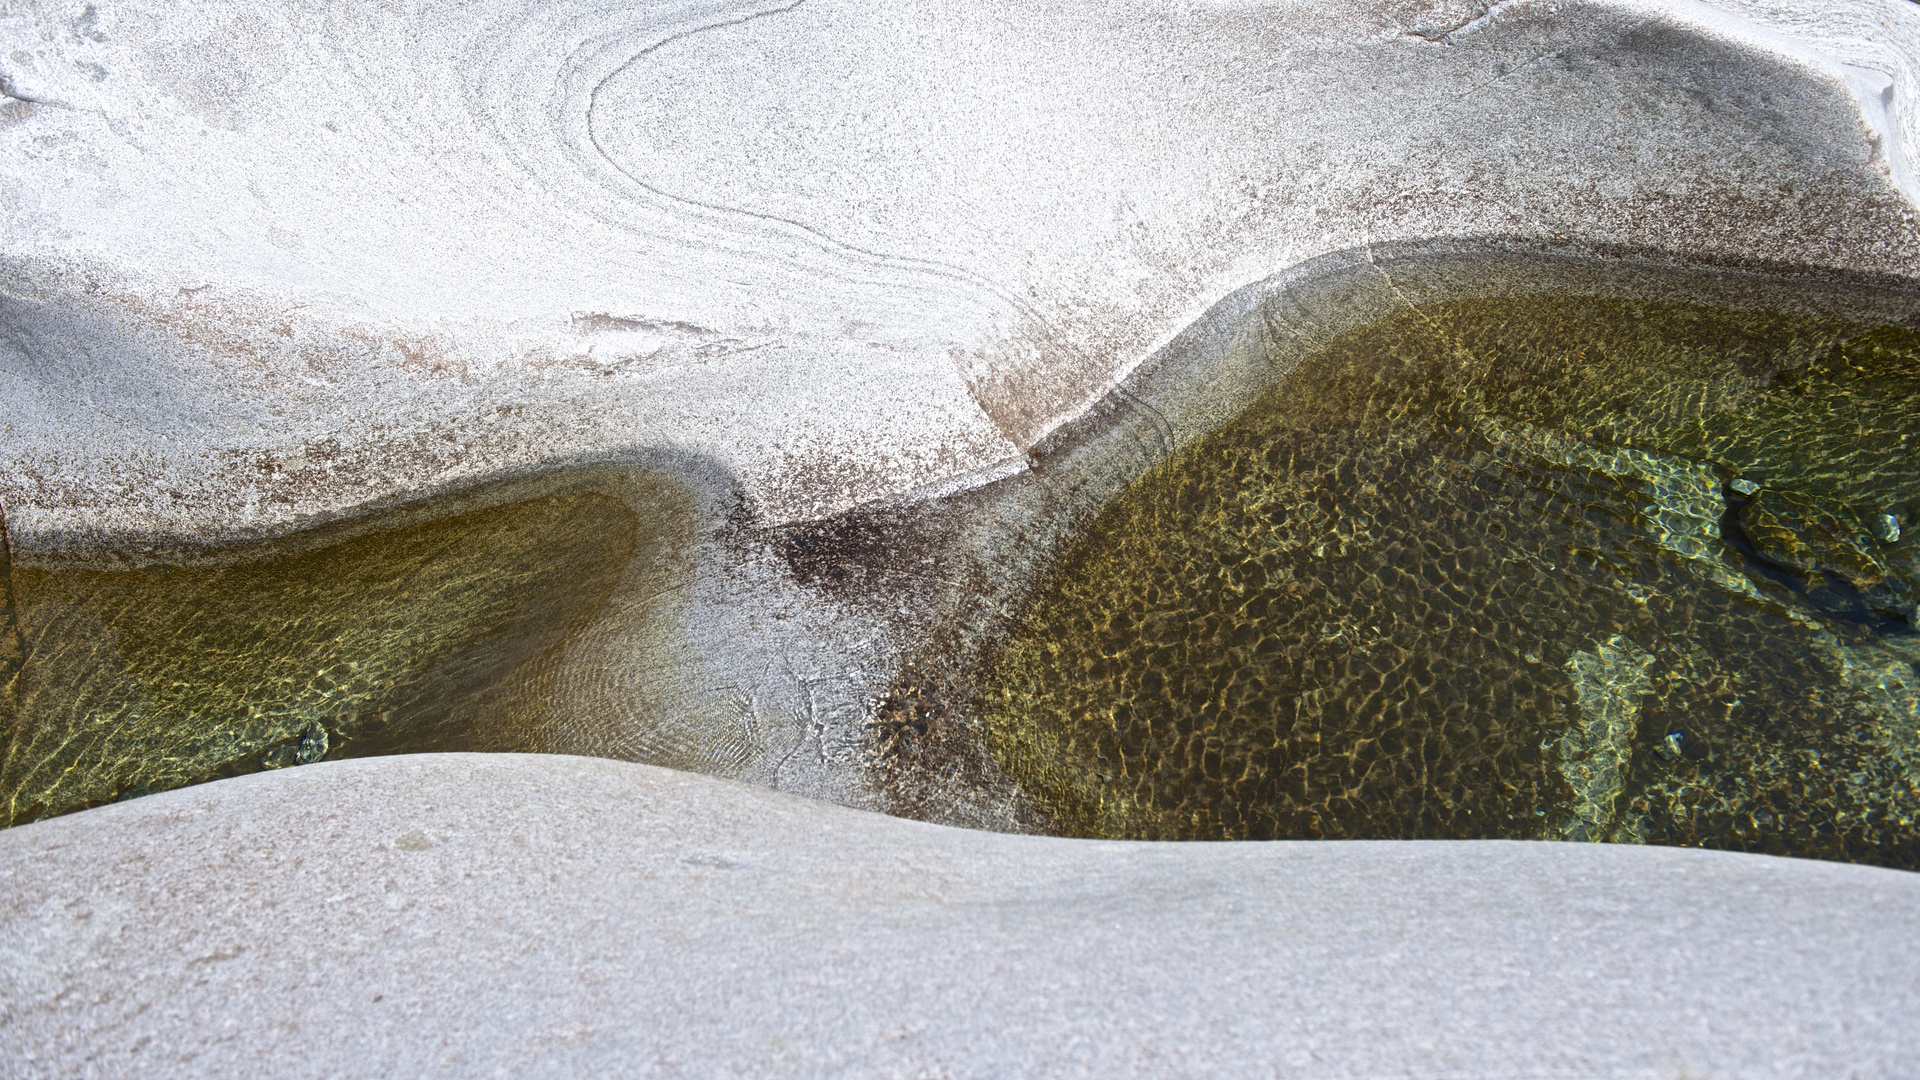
[0, 0, 1920, 541]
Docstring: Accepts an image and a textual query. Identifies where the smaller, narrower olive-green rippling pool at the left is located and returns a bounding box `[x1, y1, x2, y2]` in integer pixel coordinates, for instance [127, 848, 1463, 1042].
[0, 484, 664, 824]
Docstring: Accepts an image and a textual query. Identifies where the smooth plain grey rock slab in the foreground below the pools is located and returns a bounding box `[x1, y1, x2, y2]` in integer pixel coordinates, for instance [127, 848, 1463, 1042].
[0, 755, 1920, 1080]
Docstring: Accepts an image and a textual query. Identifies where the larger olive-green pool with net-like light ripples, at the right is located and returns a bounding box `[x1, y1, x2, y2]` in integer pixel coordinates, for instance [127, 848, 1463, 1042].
[983, 298, 1920, 869]
